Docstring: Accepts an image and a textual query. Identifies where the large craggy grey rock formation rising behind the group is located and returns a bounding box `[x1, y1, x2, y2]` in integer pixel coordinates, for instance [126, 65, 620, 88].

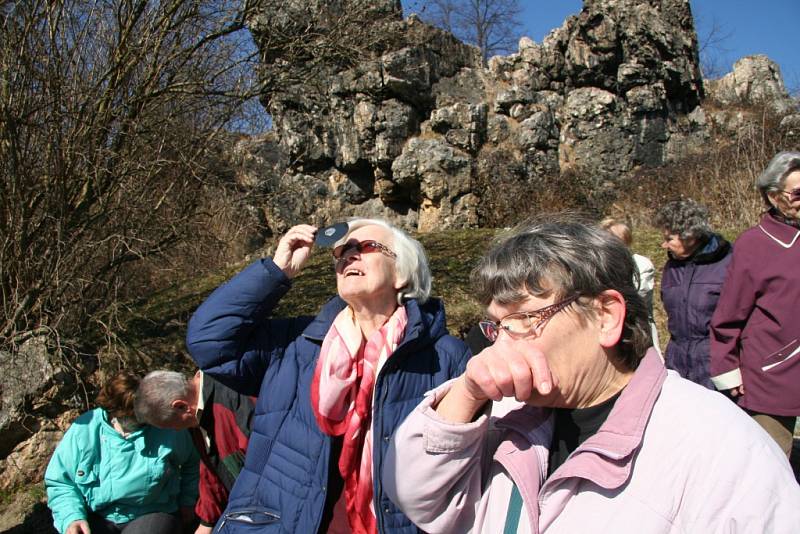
[245, 0, 706, 232]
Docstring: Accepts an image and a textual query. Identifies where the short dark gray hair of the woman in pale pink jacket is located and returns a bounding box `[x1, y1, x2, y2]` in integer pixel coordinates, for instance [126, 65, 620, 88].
[472, 213, 652, 370]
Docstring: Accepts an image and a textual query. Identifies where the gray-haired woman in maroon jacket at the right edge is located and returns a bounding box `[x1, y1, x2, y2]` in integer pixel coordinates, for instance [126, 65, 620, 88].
[711, 152, 800, 455]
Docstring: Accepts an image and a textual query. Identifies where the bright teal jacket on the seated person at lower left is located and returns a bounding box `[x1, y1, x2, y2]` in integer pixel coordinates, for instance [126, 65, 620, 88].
[44, 408, 199, 533]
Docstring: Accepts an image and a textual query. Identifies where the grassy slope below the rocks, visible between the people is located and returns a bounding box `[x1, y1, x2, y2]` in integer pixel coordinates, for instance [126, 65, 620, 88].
[117, 226, 752, 369]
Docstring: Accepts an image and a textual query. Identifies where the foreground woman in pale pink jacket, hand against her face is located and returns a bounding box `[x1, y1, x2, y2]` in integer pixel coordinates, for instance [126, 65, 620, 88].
[383, 217, 800, 534]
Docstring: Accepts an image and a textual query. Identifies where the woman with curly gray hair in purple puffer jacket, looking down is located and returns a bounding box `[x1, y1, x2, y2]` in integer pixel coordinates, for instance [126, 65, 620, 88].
[655, 200, 731, 389]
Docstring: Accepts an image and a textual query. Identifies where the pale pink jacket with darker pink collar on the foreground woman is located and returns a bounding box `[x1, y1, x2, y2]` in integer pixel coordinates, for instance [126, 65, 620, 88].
[383, 350, 800, 534]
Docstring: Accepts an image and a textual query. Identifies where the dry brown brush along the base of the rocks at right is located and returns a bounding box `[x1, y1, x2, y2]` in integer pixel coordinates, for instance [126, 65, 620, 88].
[475, 102, 800, 232]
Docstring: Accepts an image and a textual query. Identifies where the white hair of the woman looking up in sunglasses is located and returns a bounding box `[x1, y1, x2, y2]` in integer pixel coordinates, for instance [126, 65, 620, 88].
[336, 218, 431, 304]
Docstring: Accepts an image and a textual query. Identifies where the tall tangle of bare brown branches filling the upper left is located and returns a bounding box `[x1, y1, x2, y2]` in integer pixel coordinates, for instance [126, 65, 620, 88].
[0, 0, 268, 358]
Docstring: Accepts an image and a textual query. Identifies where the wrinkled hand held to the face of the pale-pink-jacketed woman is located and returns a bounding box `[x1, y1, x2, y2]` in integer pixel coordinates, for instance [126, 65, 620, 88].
[436, 335, 557, 422]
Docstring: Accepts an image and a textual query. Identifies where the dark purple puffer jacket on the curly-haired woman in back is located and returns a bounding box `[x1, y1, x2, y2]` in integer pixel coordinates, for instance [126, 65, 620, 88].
[661, 234, 732, 389]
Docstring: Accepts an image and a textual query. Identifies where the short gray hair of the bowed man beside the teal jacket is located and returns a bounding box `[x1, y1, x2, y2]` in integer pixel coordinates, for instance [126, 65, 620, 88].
[133, 371, 190, 427]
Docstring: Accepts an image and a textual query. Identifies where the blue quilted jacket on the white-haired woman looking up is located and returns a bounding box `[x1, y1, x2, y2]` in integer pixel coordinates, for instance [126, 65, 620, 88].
[187, 259, 469, 534]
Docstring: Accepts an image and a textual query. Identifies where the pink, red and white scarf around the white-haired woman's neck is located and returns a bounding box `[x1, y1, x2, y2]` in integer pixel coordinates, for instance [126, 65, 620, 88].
[311, 306, 408, 534]
